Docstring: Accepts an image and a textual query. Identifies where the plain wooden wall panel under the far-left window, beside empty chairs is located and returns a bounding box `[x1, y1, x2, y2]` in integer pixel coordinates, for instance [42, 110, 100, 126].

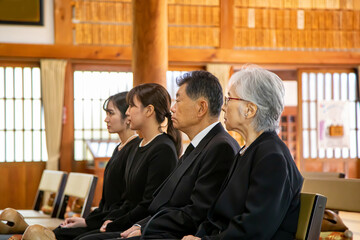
[0, 162, 45, 209]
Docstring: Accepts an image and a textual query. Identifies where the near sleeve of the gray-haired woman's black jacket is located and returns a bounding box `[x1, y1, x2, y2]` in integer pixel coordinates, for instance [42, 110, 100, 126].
[202, 154, 294, 239]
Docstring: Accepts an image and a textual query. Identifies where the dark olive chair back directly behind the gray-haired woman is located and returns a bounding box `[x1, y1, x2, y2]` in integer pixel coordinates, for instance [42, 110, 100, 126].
[295, 193, 326, 240]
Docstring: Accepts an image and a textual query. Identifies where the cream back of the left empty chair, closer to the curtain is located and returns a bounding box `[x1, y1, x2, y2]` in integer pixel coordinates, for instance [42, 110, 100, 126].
[33, 170, 67, 217]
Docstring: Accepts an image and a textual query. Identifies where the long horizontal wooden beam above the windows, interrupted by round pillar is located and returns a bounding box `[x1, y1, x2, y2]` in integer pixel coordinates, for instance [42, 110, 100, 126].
[0, 44, 360, 66]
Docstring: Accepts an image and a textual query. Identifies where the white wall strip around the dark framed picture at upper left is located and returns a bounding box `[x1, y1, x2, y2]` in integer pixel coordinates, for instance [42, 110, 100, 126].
[0, 0, 54, 44]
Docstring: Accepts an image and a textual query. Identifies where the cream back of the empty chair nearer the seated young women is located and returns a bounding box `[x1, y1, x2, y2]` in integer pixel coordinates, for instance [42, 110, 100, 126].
[57, 172, 97, 219]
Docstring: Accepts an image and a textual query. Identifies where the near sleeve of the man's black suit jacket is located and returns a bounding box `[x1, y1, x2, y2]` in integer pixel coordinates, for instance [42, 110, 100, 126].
[142, 142, 236, 237]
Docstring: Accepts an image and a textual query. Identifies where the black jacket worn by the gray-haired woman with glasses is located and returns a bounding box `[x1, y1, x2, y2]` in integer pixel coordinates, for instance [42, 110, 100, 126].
[197, 132, 303, 240]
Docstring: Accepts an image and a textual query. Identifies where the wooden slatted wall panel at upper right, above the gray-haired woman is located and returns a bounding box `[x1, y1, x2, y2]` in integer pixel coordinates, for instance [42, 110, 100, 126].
[233, 1, 359, 52]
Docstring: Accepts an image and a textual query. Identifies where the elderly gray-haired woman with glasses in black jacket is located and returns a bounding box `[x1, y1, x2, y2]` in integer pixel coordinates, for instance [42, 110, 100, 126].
[183, 66, 303, 240]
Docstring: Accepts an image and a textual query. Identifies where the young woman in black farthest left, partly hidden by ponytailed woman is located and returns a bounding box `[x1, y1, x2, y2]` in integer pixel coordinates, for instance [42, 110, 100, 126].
[54, 92, 141, 240]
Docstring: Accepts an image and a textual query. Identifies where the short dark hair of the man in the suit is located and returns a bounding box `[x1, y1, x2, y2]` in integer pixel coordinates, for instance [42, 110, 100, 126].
[176, 71, 223, 117]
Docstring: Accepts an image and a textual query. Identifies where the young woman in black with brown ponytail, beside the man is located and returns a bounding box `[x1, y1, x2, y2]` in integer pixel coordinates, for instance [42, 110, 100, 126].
[80, 83, 181, 240]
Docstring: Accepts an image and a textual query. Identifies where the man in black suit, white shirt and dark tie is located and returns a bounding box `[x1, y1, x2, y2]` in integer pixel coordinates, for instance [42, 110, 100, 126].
[110, 71, 239, 239]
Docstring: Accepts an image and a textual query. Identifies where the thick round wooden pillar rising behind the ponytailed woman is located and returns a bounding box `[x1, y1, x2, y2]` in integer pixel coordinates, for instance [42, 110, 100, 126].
[132, 0, 168, 87]
